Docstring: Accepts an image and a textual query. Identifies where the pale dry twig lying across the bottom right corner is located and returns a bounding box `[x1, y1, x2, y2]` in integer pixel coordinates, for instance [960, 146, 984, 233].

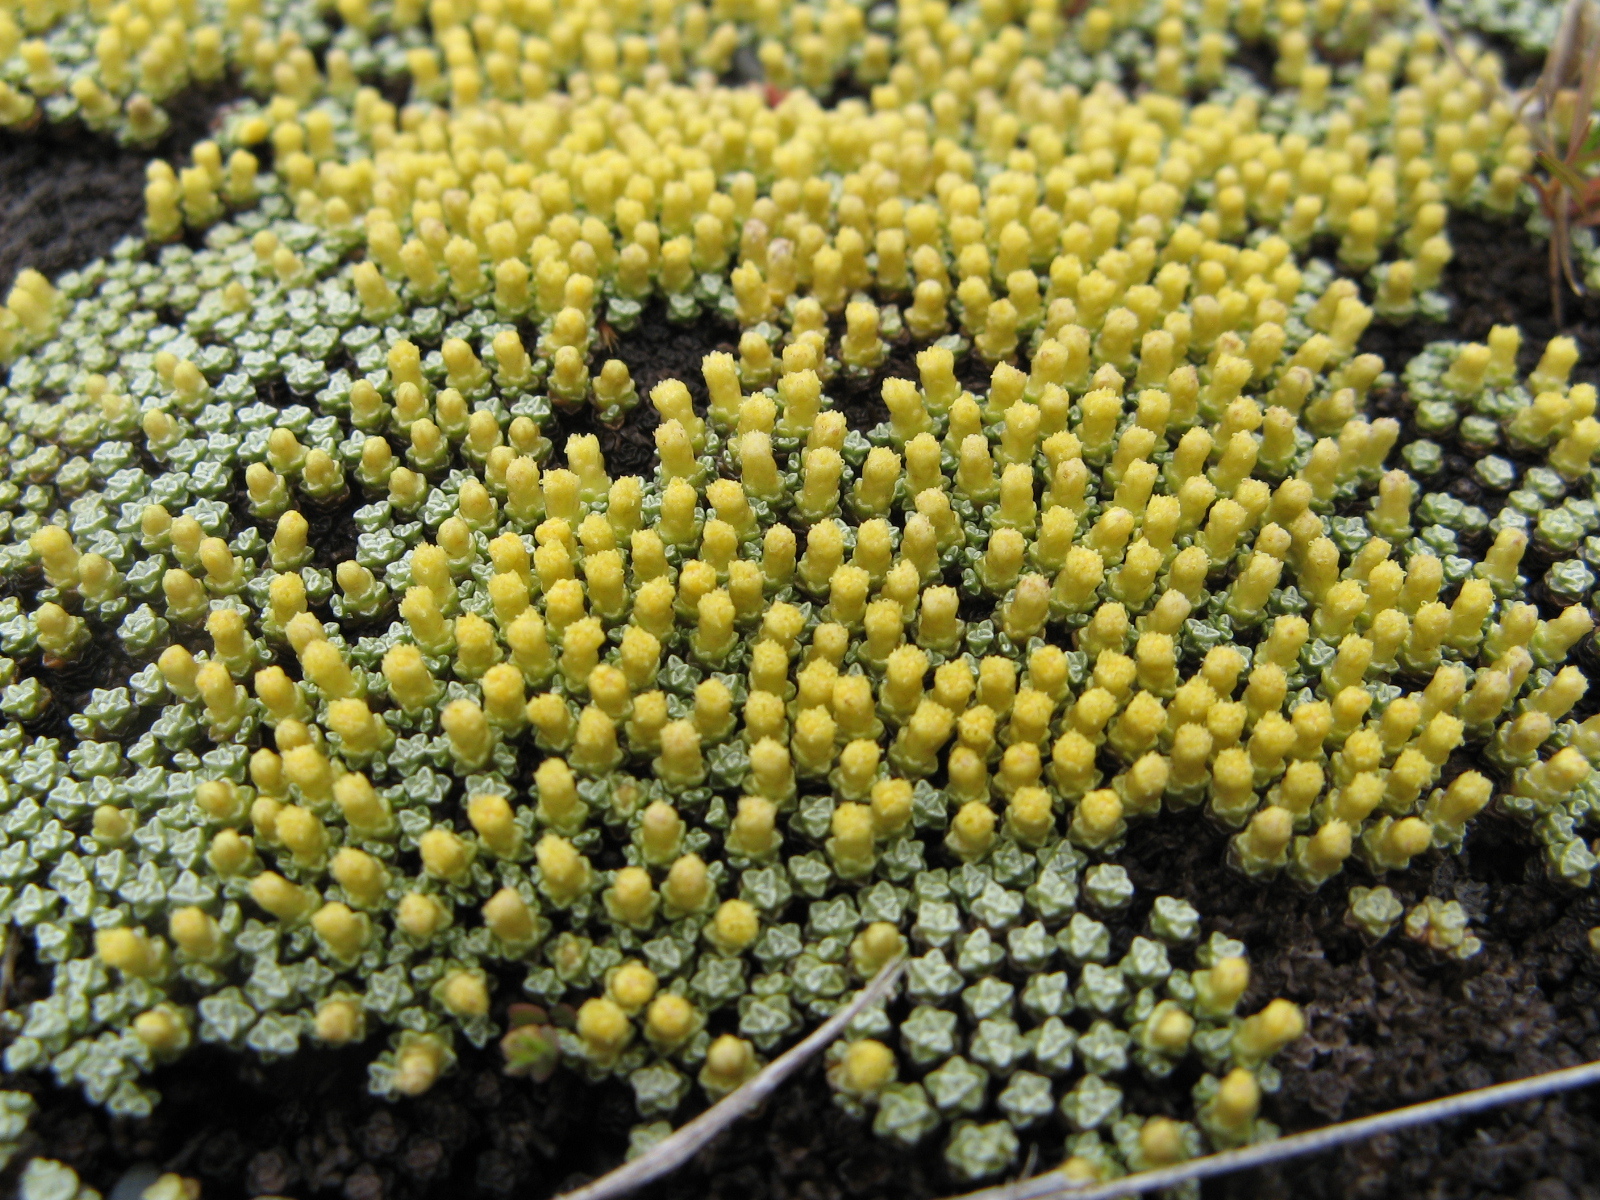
[954, 1062, 1600, 1200]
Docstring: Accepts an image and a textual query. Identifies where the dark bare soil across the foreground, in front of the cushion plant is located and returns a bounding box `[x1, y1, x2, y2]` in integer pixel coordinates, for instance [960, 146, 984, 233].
[8, 814, 1600, 1200]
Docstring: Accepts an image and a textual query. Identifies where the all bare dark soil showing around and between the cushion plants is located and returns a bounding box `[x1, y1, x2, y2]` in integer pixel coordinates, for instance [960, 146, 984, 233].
[0, 104, 1600, 1200]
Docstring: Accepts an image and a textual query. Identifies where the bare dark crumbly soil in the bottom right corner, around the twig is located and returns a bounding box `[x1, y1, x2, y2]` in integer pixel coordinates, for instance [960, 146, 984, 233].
[1123, 818, 1600, 1200]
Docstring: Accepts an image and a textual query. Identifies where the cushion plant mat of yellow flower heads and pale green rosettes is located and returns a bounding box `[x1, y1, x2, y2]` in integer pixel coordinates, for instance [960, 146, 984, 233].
[0, 0, 1600, 1178]
